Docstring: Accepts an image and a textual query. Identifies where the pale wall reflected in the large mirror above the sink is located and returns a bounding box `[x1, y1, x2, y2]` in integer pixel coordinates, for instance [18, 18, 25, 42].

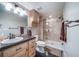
[0, 4, 27, 35]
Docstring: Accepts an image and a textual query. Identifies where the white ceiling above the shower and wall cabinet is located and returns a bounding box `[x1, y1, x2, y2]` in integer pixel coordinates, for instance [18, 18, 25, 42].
[19, 2, 65, 18]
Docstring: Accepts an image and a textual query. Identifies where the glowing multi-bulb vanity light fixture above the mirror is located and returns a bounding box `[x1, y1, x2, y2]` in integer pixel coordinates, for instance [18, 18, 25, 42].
[1, 2, 27, 16]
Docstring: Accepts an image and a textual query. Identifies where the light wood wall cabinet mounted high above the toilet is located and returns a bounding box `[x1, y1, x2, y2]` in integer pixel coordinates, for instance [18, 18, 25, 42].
[28, 10, 40, 27]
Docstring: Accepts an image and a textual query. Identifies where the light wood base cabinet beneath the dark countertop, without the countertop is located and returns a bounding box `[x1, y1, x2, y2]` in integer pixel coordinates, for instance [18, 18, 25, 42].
[0, 39, 36, 57]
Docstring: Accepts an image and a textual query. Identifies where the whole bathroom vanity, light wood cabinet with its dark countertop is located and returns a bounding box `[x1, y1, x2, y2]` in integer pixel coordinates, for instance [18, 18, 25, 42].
[0, 37, 36, 57]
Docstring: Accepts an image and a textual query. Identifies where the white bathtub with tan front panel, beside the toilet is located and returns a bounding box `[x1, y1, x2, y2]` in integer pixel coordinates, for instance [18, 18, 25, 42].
[46, 41, 64, 57]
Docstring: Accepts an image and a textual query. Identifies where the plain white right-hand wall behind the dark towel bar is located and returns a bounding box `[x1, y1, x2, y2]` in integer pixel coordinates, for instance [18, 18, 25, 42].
[63, 2, 79, 57]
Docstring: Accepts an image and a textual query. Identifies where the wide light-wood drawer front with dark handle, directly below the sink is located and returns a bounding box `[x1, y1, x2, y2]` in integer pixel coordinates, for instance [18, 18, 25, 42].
[3, 42, 28, 57]
